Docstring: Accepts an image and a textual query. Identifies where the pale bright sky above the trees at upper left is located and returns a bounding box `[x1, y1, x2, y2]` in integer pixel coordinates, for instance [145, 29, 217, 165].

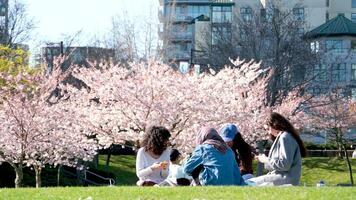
[19, 0, 159, 52]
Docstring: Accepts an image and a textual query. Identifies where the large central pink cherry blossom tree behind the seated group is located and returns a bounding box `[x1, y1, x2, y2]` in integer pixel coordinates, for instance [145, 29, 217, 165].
[66, 57, 304, 152]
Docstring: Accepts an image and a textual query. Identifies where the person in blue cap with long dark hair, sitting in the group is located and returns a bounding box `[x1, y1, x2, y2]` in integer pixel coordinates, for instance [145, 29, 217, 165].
[219, 124, 253, 178]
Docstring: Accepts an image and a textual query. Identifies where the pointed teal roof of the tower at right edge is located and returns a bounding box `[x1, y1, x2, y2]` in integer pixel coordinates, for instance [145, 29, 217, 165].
[306, 15, 356, 38]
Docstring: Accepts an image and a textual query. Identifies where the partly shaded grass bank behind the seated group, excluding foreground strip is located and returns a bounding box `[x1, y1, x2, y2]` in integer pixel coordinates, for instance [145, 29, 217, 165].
[99, 155, 356, 186]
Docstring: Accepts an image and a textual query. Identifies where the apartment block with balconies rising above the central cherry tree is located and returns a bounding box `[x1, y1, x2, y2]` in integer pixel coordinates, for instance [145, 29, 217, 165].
[158, 0, 234, 64]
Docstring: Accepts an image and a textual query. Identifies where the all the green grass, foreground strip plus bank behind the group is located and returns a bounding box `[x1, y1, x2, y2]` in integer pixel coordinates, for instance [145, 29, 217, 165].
[0, 156, 356, 200]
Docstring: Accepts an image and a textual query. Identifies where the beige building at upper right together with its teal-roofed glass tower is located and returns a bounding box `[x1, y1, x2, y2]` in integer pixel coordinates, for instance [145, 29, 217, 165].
[234, 0, 356, 99]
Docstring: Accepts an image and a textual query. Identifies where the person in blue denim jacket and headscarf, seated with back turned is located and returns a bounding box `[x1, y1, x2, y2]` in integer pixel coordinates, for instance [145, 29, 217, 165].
[183, 127, 245, 185]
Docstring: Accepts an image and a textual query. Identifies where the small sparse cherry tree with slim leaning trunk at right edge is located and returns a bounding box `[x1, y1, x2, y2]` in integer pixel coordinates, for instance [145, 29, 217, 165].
[300, 88, 356, 185]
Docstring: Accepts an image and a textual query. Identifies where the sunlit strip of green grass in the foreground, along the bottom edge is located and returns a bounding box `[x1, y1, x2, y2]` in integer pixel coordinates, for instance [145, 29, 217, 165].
[0, 186, 356, 200]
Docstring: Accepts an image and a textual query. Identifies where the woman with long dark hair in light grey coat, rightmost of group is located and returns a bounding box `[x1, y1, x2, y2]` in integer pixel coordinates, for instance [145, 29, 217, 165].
[249, 112, 307, 185]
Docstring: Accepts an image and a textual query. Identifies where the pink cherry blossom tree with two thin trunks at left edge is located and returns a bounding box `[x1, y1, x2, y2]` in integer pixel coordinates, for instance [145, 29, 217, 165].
[0, 60, 97, 187]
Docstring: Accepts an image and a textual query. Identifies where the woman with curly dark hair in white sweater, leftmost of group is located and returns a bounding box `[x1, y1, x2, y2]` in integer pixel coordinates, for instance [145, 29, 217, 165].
[136, 126, 171, 186]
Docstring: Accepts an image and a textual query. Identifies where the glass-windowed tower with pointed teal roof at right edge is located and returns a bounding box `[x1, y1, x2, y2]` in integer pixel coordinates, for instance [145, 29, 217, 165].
[306, 13, 356, 99]
